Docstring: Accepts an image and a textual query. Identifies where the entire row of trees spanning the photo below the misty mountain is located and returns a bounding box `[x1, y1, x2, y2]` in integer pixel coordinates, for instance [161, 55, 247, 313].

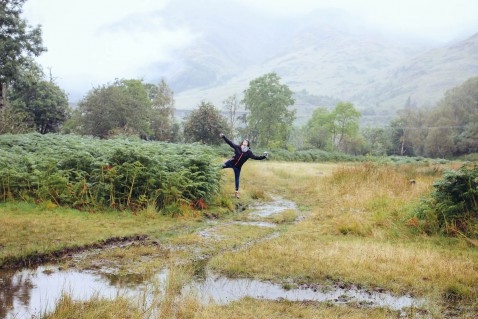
[0, 0, 478, 158]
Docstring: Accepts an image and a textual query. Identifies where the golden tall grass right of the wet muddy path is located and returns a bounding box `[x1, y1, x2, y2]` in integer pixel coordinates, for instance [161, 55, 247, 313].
[211, 162, 478, 307]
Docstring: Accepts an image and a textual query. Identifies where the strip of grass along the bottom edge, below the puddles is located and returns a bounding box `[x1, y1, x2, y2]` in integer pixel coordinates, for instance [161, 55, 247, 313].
[43, 295, 416, 319]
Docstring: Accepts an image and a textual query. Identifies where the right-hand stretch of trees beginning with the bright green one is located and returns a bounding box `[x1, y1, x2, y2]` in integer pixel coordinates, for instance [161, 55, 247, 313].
[303, 77, 478, 158]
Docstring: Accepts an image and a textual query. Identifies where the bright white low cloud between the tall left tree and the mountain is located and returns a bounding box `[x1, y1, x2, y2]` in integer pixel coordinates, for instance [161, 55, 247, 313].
[25, 0, 194, 98]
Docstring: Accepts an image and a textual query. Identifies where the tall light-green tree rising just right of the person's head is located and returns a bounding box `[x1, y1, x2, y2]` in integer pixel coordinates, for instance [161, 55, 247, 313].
[242, 73, 295, 147]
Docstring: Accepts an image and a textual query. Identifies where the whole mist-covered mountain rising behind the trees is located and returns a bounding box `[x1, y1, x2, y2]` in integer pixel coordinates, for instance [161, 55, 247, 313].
[152, 0, 478, 120]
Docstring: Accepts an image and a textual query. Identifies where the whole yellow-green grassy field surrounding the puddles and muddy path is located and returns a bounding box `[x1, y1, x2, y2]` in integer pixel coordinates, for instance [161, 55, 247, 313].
[0, 161, 478, 318]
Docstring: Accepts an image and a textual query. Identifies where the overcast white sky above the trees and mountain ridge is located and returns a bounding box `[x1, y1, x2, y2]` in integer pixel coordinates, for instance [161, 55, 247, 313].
[24, 0, 478, 100]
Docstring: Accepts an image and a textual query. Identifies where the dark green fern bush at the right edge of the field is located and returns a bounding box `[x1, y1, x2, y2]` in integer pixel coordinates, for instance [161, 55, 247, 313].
[417, 164, 478, 236]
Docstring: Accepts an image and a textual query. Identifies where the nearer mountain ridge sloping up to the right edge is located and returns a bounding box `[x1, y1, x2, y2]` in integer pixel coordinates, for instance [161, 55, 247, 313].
[360, 33, 478, 109]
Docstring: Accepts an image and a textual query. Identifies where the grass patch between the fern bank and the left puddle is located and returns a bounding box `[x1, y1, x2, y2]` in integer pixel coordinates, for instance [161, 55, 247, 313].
[0, 203, 197, 268]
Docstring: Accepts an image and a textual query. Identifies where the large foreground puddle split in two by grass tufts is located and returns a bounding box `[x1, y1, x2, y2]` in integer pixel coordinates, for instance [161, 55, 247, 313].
[0, 261, 425, 319]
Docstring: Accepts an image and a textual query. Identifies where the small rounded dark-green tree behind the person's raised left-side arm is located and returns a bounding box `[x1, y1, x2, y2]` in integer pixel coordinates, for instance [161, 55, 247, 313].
[184, 101, 230, 144]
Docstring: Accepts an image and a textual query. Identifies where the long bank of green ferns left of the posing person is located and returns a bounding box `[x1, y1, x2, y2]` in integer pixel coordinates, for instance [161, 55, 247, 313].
[0, 134, 220, 209]
